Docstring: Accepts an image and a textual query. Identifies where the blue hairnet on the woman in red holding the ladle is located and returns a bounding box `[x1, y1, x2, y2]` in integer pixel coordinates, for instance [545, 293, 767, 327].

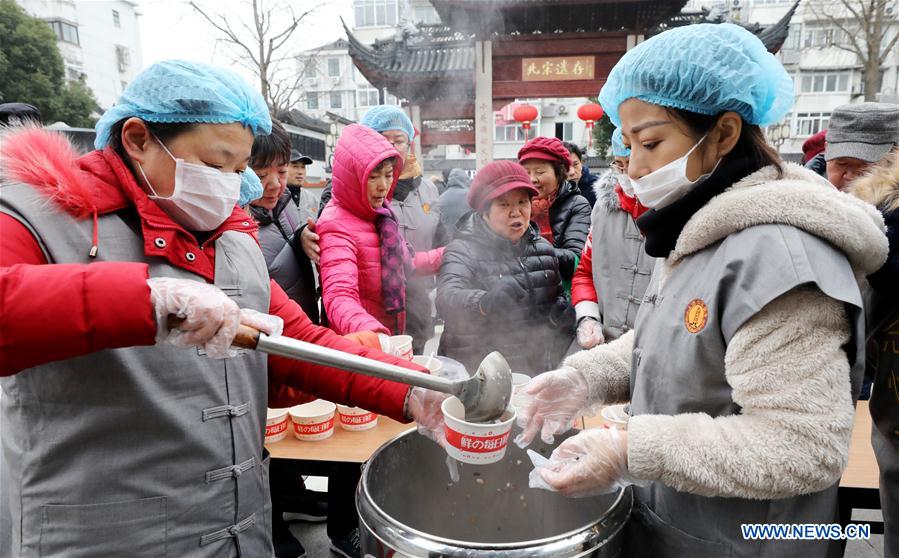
[94, 60, 272, 149]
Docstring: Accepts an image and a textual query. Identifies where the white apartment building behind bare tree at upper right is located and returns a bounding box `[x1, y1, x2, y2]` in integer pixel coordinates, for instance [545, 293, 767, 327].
[689, 0, 899, 158]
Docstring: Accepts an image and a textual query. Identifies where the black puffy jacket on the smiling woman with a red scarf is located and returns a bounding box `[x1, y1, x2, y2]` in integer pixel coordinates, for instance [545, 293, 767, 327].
[549, 181, 591, 281]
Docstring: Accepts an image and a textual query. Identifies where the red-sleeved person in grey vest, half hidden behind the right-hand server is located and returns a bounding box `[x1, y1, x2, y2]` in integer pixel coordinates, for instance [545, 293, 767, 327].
[571, 128, 655, 349]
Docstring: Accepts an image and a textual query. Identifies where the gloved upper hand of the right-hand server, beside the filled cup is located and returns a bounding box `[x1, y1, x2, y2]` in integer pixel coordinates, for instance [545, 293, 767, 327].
[515, 366, 589, 448]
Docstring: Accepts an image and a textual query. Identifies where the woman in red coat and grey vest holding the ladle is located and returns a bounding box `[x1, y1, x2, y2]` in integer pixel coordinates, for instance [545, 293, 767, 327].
[0, 61, 443, 558]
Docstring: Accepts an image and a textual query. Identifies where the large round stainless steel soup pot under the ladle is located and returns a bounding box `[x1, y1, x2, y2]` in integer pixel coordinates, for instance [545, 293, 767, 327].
[356, 431, 633, 558]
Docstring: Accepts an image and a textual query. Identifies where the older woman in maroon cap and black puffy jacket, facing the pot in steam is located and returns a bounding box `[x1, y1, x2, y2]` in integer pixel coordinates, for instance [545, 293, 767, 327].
[437, 161, 574, 374]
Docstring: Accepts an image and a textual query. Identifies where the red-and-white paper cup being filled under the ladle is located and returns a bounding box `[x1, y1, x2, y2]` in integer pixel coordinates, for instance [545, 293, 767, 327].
[441, 397, 515, 465]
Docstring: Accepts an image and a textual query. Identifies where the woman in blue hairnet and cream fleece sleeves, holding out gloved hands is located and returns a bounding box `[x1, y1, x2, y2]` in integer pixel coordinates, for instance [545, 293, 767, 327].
[518, 24, 887, 557]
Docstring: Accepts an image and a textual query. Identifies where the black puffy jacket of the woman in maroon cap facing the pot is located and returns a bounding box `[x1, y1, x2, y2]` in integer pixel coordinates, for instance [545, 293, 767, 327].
[437, 213, 574, 374]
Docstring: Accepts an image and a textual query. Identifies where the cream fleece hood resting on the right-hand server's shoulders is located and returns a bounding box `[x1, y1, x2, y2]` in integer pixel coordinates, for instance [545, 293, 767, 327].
[667, 163, 889, 275]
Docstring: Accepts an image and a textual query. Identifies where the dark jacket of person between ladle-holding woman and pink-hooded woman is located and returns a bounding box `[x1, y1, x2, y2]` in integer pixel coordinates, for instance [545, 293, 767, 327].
[246, 191, 319, 324]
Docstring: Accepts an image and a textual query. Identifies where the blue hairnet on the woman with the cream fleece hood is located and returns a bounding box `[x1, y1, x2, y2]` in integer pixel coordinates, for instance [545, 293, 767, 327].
[599, 23, 794, 127]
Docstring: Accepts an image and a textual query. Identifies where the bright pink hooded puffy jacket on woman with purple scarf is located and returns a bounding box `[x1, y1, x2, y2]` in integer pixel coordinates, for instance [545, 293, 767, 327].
[315, 124, 443, 335]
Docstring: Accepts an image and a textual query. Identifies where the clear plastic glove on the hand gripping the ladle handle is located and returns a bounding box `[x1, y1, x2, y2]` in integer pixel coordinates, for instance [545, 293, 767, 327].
[147, 277, 240, 358]
